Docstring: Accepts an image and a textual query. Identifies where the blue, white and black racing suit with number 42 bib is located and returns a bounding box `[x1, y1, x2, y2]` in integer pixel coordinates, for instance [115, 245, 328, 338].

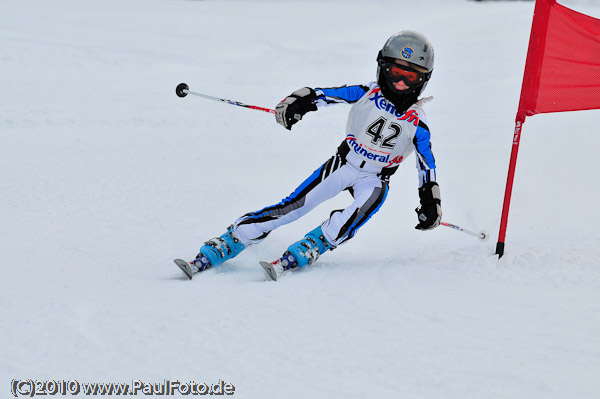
[233, 82, 435, 247]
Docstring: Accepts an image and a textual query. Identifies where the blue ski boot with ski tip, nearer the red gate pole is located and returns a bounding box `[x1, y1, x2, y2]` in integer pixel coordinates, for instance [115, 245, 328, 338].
[260, 226, 334, 281]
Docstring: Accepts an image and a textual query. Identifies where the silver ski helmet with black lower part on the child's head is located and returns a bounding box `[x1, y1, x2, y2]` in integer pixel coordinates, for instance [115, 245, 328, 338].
[377, 30, 434, 97]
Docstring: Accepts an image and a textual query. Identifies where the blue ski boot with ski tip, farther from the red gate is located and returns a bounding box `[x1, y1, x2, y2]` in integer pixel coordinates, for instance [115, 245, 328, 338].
[175, 225, 246, 280]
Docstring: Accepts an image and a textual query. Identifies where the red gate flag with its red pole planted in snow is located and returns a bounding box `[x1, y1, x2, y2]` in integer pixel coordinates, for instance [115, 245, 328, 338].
[496, 0, 600, 257]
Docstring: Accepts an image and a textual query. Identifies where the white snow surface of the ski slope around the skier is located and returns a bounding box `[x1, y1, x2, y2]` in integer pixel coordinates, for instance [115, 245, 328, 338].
[0, 0, 600, 399]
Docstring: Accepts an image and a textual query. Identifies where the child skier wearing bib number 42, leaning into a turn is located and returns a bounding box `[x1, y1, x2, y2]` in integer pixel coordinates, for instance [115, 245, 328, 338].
[176, 31, 442, 280]
